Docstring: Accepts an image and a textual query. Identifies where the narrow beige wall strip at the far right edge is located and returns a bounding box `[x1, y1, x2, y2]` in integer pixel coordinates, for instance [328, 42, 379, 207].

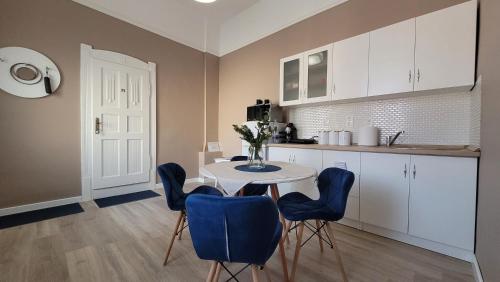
[476, 0, 500, 282]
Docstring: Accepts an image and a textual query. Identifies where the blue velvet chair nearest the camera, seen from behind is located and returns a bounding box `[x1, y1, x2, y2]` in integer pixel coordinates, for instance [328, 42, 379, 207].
[186, 195, 282, 281]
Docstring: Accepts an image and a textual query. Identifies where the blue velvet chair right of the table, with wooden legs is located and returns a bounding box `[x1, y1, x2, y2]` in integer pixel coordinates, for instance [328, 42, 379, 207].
[278, 167, 354, 281]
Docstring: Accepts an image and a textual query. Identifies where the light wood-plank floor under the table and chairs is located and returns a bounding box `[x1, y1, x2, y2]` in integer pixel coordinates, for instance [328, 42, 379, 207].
[0, 185, 474, 282]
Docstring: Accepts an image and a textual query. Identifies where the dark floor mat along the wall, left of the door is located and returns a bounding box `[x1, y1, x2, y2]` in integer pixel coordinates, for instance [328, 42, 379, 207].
[0, 203, 84, 229]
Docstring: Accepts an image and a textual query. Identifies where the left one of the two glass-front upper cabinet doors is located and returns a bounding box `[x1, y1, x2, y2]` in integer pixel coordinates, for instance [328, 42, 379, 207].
[280, 54, 304, 106]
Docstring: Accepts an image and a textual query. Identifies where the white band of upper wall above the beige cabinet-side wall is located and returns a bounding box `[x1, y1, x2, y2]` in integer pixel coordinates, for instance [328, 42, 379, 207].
[218, 0, 349, 57]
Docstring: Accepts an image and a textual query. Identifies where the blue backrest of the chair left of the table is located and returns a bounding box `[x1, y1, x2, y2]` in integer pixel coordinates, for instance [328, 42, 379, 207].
[158, 163, 186, 211]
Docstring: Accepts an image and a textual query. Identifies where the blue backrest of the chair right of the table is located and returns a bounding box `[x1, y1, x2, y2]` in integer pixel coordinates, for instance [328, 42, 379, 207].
[318, 167, 354, 218]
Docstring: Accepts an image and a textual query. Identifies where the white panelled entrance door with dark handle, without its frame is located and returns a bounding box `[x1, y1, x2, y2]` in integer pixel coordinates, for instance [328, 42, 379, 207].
[91, 59, 151, 189]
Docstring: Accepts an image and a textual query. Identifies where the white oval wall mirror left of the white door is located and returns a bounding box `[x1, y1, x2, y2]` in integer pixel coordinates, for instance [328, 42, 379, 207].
[0, 47, 61, 98]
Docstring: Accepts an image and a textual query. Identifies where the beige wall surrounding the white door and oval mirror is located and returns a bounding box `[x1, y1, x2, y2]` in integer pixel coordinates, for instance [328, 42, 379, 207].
[0, 0, 204, 208]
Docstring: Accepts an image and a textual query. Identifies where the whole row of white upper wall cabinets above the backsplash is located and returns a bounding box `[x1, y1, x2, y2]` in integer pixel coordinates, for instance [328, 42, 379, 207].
[280, 0, 477, 106]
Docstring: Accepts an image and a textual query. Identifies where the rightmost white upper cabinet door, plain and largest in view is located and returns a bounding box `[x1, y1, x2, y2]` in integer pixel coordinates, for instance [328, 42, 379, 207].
[414, 0, 477, 91]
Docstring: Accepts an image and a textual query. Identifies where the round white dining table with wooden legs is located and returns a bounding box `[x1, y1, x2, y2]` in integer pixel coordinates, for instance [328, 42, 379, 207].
[200, 161, 317, 281]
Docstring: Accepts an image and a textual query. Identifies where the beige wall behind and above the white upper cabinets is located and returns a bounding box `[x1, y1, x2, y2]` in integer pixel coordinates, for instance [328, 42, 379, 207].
[219, 0, 464, 156]
